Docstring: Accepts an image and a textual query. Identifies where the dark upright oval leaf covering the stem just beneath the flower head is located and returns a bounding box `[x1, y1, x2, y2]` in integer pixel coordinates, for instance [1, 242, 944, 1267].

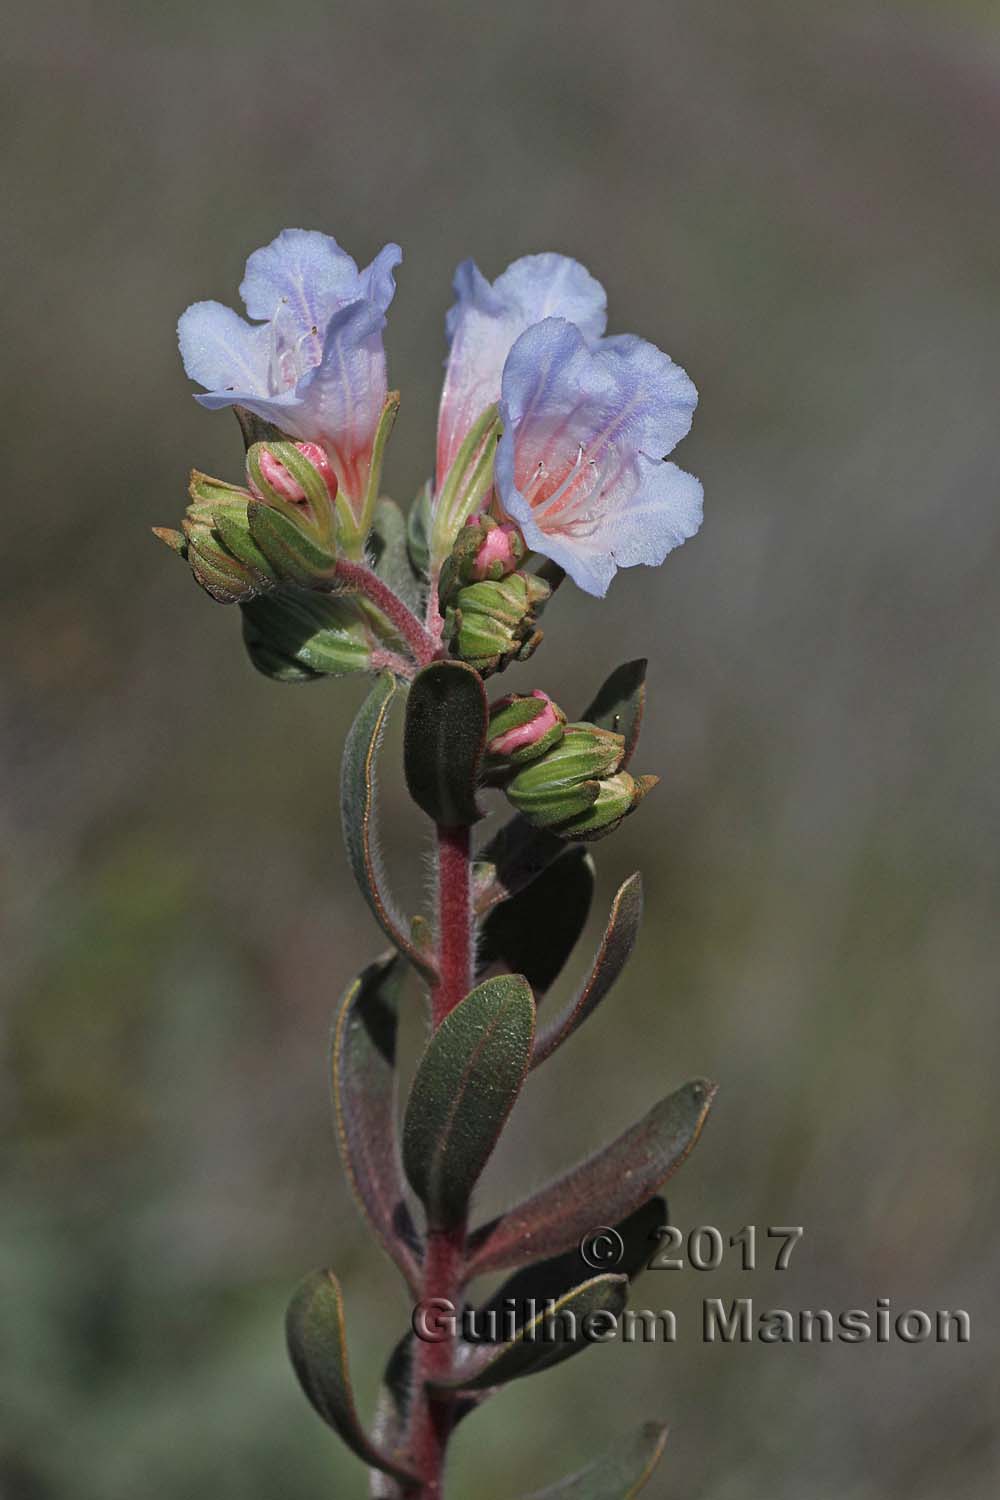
[403, 662, 489, 828]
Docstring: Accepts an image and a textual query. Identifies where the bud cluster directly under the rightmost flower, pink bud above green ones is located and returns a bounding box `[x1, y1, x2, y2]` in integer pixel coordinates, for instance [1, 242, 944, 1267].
[438, 515, 552, 677]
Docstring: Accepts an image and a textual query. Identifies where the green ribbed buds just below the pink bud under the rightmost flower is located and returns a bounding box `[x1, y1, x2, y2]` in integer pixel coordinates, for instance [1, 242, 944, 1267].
[445, 573, 552, 677]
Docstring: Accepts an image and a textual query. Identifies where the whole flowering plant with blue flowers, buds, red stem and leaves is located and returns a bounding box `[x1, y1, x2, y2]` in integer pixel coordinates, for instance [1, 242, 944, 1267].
[157, 230, 714, 1500]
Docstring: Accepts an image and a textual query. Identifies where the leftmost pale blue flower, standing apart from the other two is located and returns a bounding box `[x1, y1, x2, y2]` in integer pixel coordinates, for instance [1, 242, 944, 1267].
[177, 230, 402, 515]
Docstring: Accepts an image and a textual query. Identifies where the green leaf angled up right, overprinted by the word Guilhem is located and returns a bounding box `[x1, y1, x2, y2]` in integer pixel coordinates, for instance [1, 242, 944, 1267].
[432, 1275, 628, 1391]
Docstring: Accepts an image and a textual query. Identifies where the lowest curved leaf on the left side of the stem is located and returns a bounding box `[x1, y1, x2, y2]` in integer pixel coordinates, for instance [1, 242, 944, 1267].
[285, 1271, 414, 1481]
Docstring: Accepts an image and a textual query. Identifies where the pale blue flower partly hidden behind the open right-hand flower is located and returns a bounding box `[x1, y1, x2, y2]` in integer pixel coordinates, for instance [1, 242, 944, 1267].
[438, 254, 607, 485]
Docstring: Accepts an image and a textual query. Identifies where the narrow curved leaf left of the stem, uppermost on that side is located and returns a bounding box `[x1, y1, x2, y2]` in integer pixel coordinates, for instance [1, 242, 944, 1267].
[340, 672, 435, 981]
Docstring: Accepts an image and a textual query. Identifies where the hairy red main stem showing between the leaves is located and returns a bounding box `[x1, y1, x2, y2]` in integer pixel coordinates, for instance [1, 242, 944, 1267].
[409, 827, 472, 1500]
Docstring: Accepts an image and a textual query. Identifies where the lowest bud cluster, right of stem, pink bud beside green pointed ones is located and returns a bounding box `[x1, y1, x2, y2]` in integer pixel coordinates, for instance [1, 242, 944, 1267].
[486, 692, 658, 840]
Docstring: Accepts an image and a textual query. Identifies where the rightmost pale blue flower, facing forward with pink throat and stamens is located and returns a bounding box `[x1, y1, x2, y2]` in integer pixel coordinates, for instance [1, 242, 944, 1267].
[495, 318, 702, 597]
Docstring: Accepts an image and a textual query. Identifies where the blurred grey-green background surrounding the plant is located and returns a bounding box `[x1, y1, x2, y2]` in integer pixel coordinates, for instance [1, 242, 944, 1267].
[0, 0, 1000, 1500]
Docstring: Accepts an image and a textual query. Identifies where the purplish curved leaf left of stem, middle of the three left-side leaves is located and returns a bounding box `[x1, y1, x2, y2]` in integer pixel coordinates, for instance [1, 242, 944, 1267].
[330, 954, 421, 1295]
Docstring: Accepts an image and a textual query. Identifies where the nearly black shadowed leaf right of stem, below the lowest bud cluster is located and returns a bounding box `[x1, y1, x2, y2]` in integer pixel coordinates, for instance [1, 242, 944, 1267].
[478, 846, 594, 999]
